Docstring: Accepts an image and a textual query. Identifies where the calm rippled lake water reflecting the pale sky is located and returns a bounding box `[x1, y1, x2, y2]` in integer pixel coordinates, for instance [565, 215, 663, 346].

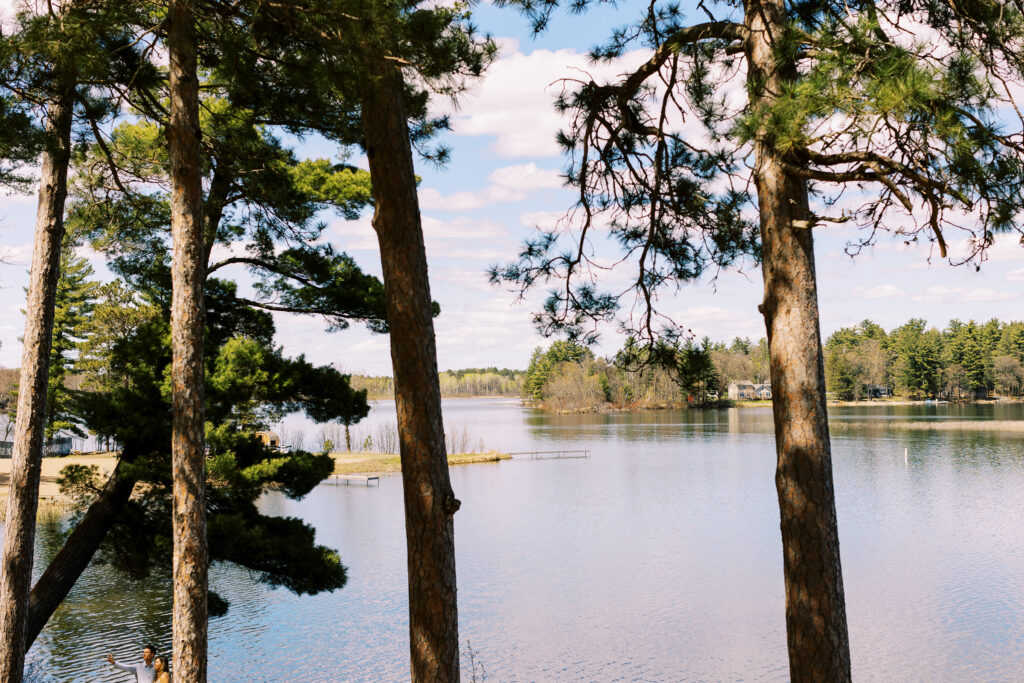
[19, 399, 1024, 683]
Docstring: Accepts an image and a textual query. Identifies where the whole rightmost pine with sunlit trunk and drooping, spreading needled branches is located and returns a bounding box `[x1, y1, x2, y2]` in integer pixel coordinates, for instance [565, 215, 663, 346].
[495, 0, 1024, 681]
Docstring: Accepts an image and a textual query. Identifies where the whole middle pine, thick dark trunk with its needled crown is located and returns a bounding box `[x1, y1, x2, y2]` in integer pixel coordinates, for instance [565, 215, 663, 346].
[217, 0, 494, 681]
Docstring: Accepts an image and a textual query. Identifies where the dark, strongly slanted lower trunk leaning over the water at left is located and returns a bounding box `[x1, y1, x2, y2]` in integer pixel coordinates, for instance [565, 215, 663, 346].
[25, 453, 135, 650]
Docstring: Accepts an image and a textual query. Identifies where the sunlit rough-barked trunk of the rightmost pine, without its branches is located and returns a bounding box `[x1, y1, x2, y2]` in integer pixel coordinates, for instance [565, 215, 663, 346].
[745, 0, 850, 682]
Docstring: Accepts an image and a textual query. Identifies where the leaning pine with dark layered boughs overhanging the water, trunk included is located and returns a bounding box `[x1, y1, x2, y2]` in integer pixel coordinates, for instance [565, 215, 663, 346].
[12, 0, 395, 642]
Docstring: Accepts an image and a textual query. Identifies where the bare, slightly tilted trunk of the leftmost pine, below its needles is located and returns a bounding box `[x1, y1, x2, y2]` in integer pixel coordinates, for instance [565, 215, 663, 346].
[0, 85, 75, 683]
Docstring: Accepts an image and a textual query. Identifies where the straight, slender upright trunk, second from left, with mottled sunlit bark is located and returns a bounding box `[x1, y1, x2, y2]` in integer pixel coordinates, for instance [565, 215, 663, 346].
[167, 0, 209, 683]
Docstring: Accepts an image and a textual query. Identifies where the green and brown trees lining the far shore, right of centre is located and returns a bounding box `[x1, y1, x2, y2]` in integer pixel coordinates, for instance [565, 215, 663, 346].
[522, 318, 1024, 412]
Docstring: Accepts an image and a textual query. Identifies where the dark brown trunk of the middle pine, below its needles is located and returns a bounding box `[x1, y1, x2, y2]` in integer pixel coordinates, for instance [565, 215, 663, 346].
[362, 63, 460, 683]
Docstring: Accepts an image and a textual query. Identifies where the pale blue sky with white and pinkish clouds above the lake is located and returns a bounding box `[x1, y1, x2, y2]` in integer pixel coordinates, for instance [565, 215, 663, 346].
[0, 2, 1024, 375]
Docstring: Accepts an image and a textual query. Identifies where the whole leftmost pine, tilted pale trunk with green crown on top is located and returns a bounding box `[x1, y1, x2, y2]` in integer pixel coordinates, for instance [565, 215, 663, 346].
[0, 0, 155, 683]
